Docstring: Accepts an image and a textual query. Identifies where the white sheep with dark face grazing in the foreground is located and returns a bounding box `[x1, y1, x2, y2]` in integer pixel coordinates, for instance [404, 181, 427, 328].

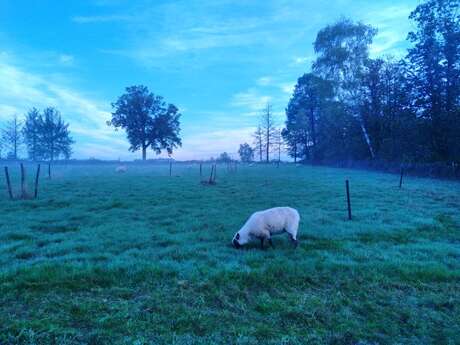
[232, 207, 300, 249]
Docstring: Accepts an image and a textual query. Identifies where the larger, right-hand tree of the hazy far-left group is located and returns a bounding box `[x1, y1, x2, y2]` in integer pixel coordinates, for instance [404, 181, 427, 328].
[36, 107, 74, 161]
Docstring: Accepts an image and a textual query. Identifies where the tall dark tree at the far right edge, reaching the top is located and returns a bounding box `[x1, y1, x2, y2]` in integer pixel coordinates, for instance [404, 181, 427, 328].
[407, 0, 460, 161]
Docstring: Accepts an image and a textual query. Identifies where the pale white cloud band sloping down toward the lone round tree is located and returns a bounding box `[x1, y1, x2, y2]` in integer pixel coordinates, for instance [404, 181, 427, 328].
[0, 55, 129, 158]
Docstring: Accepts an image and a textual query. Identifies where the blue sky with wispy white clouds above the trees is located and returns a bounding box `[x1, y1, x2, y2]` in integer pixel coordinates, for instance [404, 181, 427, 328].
[0, 0, 420, 160]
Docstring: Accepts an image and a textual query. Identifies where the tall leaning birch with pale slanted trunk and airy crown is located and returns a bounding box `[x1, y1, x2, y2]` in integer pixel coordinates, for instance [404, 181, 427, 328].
[313, 19, 377, 158]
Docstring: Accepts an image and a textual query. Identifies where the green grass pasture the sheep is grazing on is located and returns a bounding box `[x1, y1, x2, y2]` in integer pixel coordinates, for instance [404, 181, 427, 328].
[0, 164, 460, 345]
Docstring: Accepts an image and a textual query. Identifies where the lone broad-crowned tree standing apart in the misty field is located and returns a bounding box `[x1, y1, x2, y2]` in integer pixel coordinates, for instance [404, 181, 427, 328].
[108, 85, 182, 160]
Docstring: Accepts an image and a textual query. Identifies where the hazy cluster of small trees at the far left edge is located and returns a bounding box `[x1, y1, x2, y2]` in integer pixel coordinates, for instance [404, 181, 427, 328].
[0, 107, 74, 161]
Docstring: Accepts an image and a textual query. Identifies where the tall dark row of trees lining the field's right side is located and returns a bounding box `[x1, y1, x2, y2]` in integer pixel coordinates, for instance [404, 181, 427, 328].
[282, 0, 460, 162]
